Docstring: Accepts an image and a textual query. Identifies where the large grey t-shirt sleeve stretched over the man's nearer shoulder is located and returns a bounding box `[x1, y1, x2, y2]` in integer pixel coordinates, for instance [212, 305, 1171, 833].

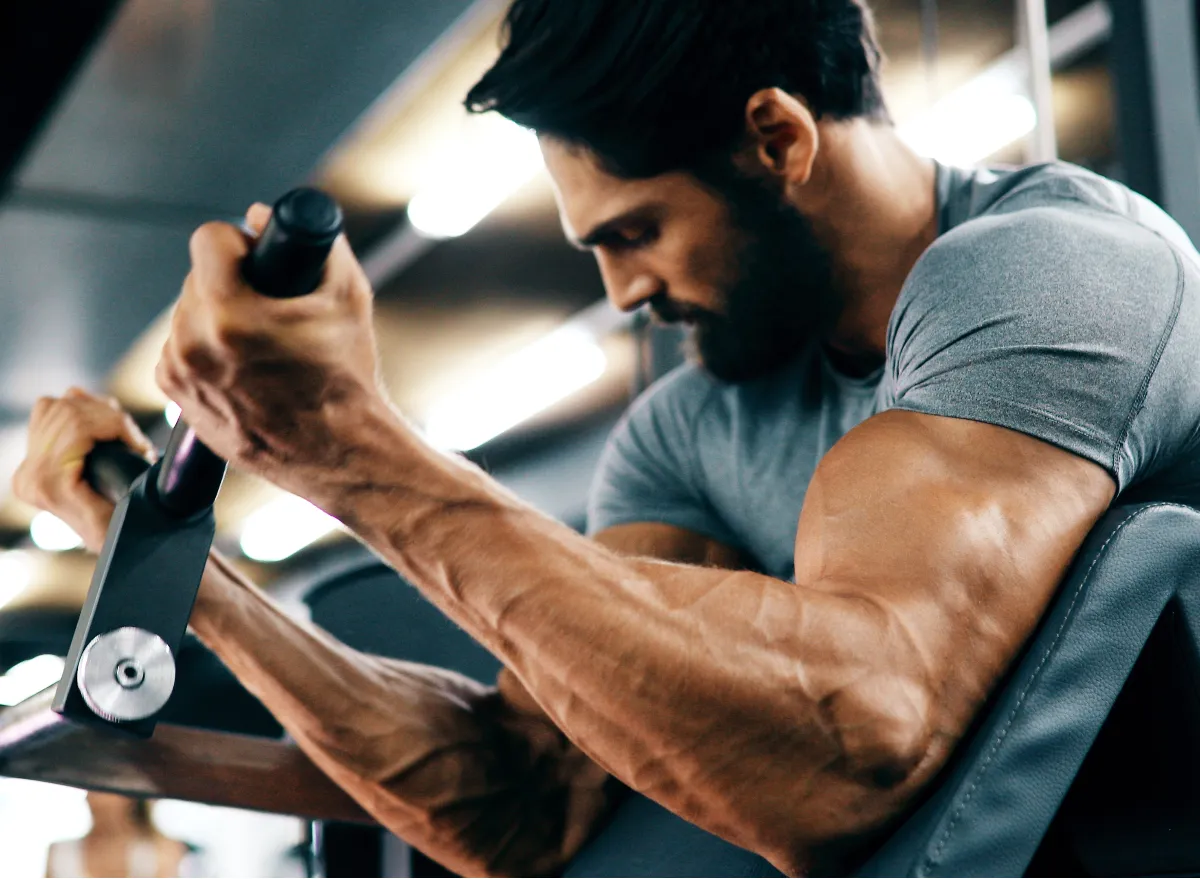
[888, 203, 1182, 489]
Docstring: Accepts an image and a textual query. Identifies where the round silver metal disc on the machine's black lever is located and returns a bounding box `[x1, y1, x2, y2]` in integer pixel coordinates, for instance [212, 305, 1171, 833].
[76, 626, 175, 723]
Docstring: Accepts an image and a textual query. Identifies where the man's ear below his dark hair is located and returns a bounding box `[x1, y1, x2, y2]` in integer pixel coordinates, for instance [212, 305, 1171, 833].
[746, 88, 818, 185]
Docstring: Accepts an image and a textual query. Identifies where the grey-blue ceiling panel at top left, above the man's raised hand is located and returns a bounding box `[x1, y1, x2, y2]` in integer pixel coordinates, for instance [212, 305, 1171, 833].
[18, 0, 480, 210]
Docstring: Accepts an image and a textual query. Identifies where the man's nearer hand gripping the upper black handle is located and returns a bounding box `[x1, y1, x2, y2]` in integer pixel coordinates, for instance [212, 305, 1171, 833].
[156, 204, 386, 488]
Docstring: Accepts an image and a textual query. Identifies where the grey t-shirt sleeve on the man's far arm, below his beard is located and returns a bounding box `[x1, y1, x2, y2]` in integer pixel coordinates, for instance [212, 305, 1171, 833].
[587, 370, 738, 546]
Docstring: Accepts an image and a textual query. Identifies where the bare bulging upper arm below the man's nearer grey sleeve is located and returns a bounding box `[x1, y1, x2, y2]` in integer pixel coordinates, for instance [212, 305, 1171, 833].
[796, 411, 1115, 726]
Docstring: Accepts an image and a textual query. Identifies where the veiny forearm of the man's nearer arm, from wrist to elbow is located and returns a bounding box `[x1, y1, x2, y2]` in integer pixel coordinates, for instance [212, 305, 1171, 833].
[310, 405, 926, 871]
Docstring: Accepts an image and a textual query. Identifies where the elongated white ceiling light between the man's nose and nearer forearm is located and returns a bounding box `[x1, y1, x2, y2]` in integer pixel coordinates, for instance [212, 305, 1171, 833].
[425, 324, 607, 452]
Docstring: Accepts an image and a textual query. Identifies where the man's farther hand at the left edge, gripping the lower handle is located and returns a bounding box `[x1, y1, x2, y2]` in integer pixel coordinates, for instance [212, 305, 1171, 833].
[12, 388, 154, 552]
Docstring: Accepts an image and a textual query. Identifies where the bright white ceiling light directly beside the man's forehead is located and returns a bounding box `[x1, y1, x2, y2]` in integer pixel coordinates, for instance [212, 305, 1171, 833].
[408, 113, 542, 238]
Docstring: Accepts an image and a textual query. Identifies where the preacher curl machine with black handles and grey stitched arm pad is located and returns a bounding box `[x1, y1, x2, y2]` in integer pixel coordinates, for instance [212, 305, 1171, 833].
[0, 190, 1200, 877]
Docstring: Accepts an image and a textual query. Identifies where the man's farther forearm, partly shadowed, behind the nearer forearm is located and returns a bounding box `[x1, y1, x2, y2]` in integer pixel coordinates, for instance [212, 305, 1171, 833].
[192, 554, 619, 875]
